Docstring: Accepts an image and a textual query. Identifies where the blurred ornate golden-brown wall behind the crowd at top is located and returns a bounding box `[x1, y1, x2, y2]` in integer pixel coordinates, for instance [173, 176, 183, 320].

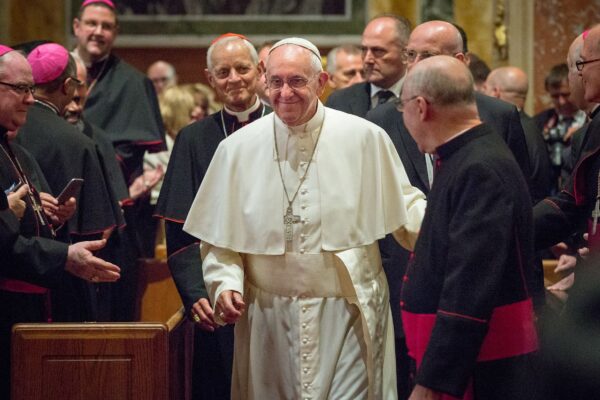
[0, 0, 600, 111]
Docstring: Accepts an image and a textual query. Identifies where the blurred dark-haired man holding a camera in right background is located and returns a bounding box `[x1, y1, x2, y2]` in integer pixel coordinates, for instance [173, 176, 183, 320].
[533, 63, 586, 193]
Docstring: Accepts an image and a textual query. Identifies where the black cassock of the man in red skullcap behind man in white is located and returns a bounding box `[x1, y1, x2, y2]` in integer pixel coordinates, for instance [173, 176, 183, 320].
[156, 105, 271, 400]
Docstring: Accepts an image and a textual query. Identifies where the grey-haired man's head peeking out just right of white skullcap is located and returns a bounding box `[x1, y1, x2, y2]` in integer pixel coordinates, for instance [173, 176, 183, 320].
[327, 44, 365, 90]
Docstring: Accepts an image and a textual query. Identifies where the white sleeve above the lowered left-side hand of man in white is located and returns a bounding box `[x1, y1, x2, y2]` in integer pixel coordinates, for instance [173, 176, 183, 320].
[200, 242, 244, 318]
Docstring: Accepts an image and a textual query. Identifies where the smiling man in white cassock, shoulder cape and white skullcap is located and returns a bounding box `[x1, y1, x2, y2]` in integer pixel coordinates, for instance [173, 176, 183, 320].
[184, 38, 425, 400]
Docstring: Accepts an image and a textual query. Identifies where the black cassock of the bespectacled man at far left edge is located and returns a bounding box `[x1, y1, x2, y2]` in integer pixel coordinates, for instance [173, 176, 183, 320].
[0, 128, 68, 398]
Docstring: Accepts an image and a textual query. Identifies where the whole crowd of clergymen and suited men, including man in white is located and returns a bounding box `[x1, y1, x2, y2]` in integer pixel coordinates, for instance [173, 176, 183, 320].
[0, 0, 600, 400]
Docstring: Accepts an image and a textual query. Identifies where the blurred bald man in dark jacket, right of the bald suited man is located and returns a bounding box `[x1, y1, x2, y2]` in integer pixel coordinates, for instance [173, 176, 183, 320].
[484, 67, 552, 203]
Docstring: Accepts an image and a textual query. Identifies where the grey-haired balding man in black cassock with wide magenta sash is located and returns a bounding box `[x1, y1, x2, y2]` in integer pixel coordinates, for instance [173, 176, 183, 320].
[400, 56, 538, 400]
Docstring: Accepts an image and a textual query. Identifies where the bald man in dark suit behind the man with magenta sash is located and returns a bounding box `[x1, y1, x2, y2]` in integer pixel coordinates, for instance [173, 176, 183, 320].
[367, 21, 541, 391]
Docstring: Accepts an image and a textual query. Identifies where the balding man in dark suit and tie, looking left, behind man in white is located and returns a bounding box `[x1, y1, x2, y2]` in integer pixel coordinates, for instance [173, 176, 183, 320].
[326, 15, 411, 117]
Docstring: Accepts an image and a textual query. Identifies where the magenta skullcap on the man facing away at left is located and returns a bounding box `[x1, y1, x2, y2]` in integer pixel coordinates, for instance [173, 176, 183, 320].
[27, 43, 69, 85]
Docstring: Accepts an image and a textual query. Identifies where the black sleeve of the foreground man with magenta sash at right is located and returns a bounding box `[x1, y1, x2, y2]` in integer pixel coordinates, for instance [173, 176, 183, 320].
[416, 166, 516, 397]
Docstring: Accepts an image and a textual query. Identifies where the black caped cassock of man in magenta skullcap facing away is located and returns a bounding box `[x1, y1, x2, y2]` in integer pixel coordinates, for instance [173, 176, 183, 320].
[16, 102, 123, 321]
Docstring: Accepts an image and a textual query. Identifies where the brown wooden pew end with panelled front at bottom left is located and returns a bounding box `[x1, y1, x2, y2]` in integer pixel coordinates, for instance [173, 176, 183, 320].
[11, 309, 193, 400]
